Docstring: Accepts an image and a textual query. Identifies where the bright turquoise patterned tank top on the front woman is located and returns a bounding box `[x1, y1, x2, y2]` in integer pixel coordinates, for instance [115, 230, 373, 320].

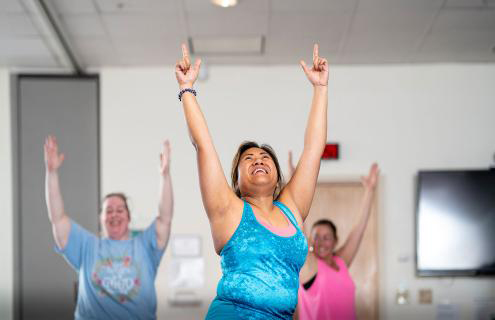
[207, 201, 308, 319]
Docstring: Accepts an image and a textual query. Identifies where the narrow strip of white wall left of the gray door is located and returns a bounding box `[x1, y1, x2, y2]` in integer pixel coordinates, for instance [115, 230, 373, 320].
[0, 69, 14, 319]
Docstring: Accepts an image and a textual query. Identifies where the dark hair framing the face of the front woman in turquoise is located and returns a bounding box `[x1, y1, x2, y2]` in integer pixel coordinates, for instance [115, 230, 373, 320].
[230, 141, 284, 199]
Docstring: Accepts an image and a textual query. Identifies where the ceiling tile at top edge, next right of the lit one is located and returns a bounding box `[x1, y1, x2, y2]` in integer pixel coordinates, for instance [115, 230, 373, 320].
[271, 0, 357, 15]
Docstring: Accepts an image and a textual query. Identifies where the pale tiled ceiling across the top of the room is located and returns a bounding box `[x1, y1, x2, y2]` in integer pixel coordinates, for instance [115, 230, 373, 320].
[0, 0, 495, 69]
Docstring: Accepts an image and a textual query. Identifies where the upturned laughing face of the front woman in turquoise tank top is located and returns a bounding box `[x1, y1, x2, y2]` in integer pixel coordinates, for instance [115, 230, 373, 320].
[237, 148, 278, 196]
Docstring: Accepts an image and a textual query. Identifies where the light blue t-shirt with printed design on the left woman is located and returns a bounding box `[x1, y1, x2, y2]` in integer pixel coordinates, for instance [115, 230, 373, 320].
[57, 221, 164, 320]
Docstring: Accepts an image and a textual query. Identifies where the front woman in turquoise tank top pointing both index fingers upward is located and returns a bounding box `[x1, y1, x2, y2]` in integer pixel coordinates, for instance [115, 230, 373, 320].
[175, 45, 328, 319]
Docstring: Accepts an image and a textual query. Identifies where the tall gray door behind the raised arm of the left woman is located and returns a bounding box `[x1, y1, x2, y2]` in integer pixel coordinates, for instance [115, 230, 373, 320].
[16, 76, 100, 320]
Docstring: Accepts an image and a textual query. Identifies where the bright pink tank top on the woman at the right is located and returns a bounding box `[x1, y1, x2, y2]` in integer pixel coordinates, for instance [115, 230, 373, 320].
[298, 256, 356, 320]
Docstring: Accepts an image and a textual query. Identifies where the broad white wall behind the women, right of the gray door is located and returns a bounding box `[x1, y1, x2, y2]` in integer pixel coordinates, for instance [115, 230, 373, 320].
[100, 65, 495, 319]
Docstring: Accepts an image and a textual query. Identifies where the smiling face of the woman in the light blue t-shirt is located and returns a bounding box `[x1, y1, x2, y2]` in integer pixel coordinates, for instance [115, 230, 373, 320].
[101, 196, 130, 240]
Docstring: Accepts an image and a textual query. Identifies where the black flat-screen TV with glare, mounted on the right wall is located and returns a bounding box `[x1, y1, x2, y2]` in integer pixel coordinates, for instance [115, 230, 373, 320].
[416, 169, 495, 276]
